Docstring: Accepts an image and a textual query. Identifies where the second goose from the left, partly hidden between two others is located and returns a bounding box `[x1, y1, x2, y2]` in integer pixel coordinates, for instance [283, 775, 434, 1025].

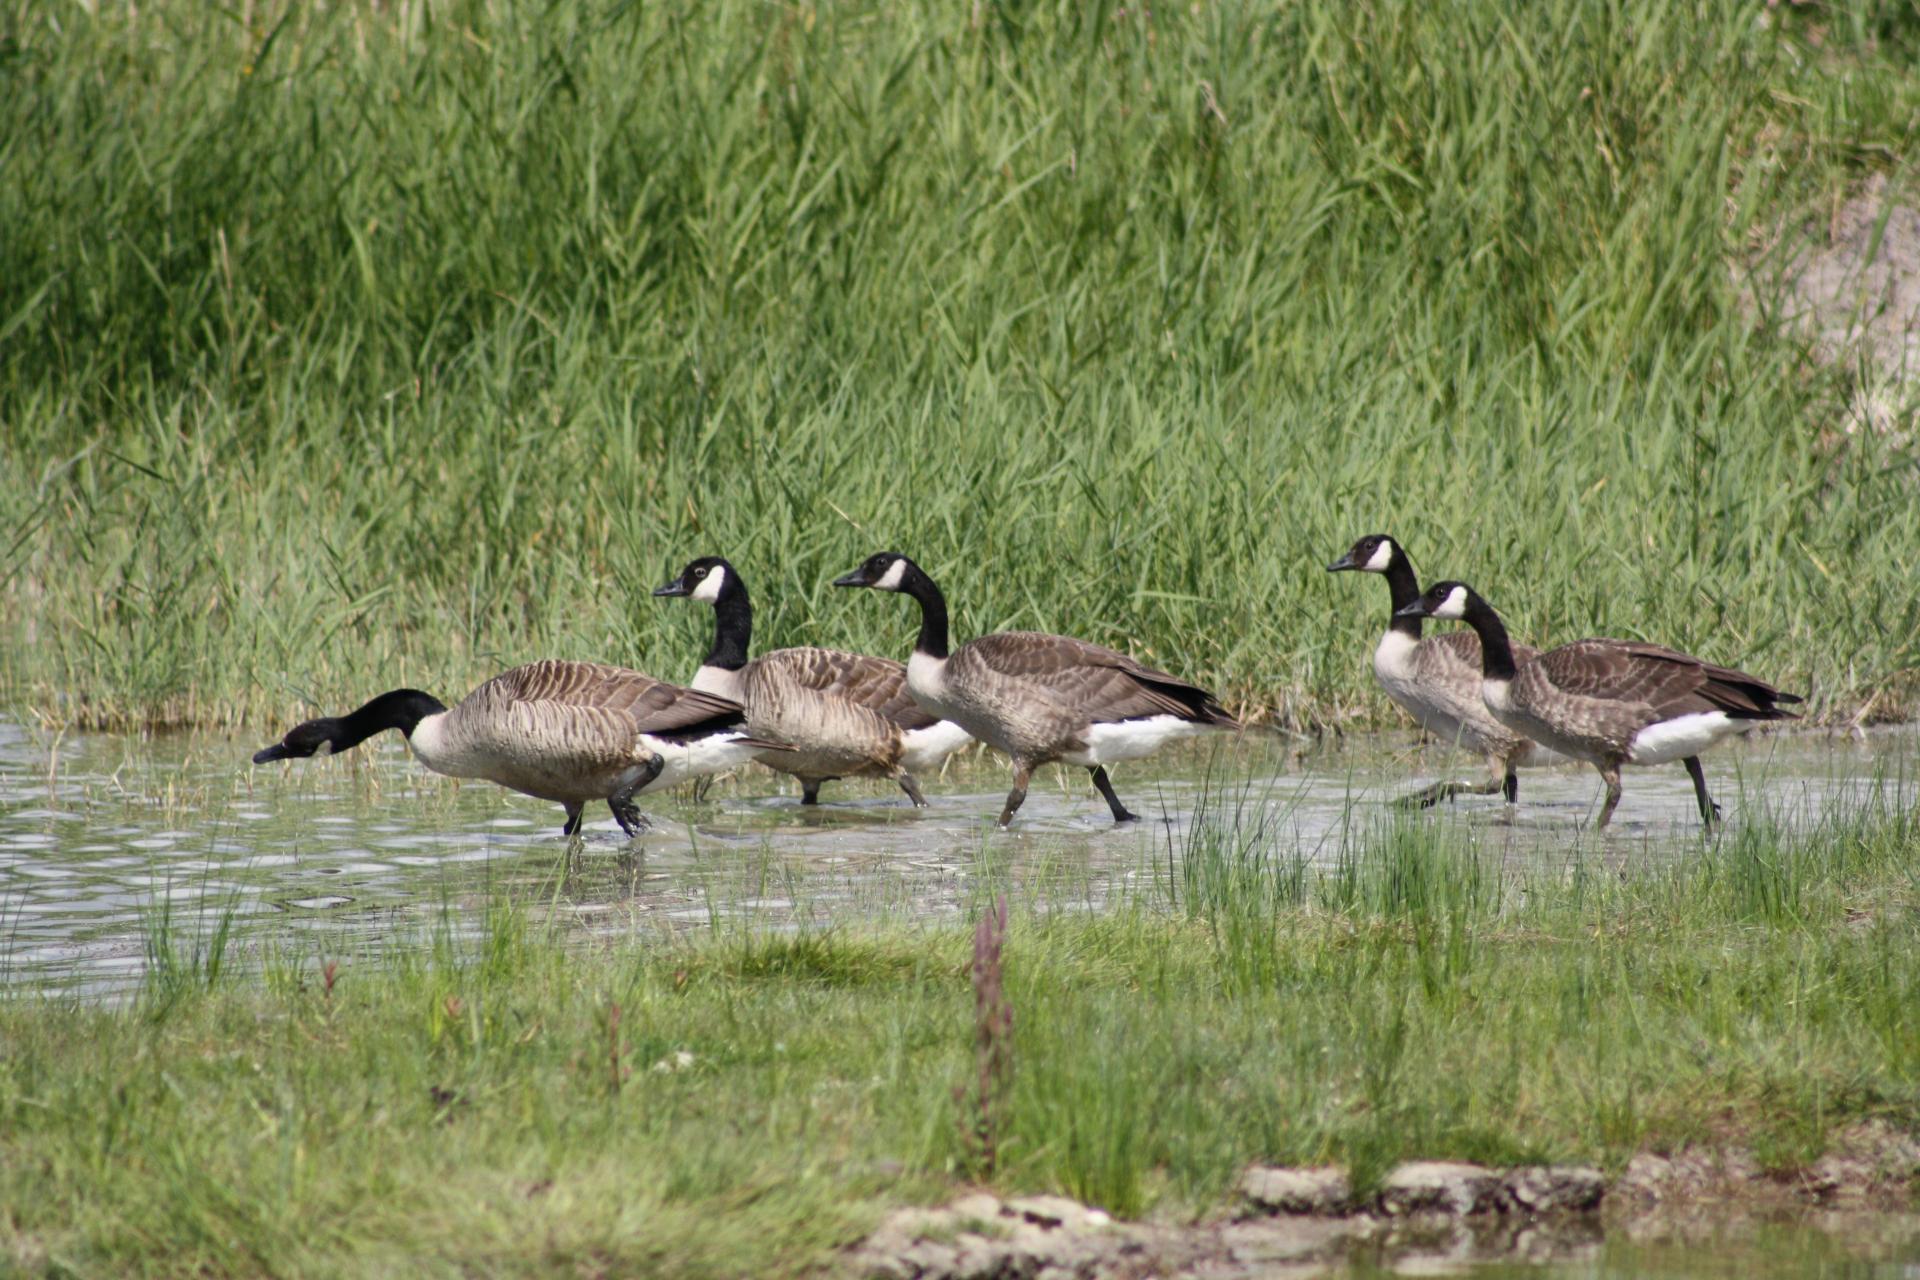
[655, 557, 968, 808]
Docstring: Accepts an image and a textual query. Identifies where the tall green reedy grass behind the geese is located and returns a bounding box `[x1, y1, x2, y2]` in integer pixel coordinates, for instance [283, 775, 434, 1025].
[0, 0, 1920, 725]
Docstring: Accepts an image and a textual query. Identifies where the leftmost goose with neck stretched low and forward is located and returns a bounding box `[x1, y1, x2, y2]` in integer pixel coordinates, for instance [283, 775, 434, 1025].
[253, 660, 781, 835]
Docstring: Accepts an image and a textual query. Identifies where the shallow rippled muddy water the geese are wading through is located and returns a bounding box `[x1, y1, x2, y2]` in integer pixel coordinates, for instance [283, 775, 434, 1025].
[0, 722, 1920, 992]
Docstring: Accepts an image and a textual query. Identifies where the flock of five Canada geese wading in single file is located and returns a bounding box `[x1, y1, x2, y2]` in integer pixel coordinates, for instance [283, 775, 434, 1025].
[253, 533, 1799, 835]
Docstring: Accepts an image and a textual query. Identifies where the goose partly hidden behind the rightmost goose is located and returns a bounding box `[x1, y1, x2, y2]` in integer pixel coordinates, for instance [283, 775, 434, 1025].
[1327, 533, 1551, 806]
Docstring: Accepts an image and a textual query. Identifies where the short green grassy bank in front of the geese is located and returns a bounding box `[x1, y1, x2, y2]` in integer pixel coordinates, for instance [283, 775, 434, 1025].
[0, 787, 1920, 1276]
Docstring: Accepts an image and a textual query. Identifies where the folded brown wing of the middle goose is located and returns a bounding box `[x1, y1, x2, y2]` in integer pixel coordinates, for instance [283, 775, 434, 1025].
[950, 631, 1236, 727]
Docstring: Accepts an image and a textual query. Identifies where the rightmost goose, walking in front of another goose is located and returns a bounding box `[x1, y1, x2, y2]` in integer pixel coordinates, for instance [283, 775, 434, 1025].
[1394, 581, 1799, 827]
